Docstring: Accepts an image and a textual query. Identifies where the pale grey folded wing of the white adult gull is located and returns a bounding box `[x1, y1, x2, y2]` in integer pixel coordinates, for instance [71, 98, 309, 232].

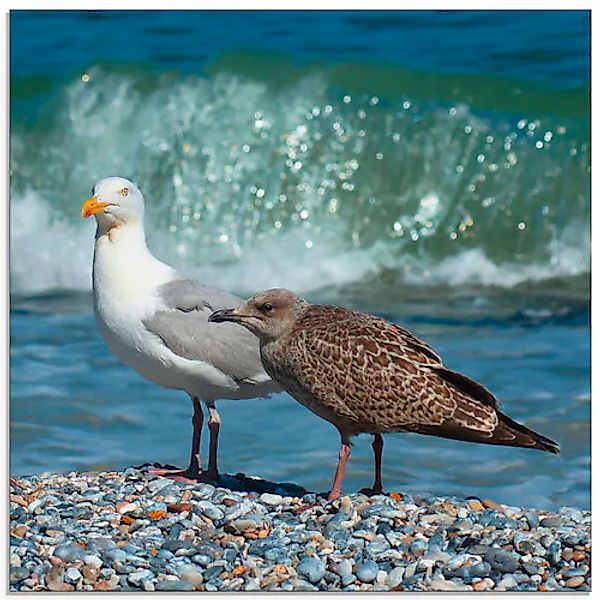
[143, 279, 269, 383]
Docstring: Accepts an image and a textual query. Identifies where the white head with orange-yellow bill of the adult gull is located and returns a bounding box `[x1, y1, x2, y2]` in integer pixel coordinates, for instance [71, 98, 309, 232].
[81, 177, 144, 229]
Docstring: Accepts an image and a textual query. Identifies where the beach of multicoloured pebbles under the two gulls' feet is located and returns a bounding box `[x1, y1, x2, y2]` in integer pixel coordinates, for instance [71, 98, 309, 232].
[10, 467, 591, 592]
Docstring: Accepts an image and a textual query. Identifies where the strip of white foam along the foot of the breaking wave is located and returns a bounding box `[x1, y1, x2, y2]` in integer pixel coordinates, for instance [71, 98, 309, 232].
[11, 186, 590, 295]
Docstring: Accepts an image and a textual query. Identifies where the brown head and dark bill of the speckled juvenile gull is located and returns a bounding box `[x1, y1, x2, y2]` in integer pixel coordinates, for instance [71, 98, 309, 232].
[208, 289, 307, 343]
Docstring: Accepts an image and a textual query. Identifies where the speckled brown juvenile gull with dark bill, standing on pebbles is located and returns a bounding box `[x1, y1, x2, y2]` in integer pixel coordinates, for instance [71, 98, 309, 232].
[208, 289, 560, 500]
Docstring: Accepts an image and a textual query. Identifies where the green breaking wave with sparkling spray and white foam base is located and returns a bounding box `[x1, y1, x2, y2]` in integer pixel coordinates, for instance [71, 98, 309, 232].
[11, 61, 590, 294]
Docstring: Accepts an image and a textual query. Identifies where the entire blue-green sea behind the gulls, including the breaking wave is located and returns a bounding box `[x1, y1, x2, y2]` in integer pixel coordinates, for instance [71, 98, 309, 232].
[10, 11, 591, 508]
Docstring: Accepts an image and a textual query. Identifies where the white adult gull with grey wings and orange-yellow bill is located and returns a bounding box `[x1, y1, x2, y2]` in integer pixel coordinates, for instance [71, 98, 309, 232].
[81, 177, 281, 480]
